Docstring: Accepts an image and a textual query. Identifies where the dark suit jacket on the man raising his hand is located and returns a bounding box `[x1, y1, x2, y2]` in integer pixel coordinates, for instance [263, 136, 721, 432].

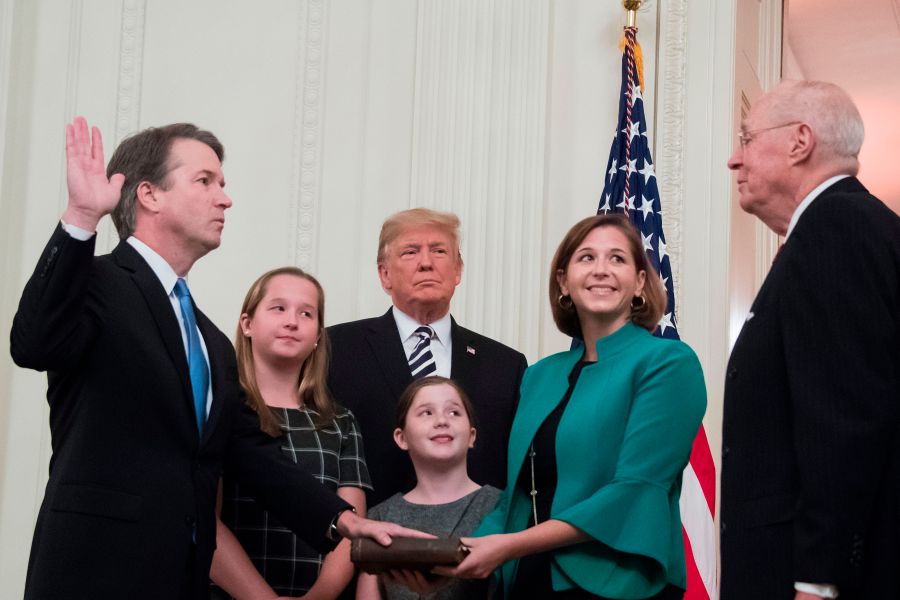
[11, 228, 346, 600]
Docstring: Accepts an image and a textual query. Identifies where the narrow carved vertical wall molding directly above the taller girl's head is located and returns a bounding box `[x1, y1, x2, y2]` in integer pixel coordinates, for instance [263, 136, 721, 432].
[290, 0, 328, 269]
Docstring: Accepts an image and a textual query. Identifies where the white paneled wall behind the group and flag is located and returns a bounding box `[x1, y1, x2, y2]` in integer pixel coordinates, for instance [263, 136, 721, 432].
[0, 0, 752, 598]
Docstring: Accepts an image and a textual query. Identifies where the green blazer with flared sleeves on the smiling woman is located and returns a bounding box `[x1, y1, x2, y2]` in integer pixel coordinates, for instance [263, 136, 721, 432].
[474, 323, 706, 598]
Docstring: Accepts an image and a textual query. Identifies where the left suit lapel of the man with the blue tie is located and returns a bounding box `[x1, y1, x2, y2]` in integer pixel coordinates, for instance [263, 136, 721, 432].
[112, 241, 196, 430]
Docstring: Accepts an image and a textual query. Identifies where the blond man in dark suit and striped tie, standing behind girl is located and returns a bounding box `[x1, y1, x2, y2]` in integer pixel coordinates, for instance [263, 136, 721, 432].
[328, 208, 527, 505]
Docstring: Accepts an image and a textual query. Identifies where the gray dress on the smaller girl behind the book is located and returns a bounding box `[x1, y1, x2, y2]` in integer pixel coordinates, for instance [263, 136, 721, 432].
[369, 485, 500, 600]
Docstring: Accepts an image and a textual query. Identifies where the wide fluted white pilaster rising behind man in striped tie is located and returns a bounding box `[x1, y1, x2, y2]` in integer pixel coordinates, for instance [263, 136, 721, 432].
[410, 0, 552, 356]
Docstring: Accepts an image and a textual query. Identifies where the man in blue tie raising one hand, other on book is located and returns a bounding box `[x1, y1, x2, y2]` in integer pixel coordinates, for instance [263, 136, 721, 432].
[10, 117, 422, 600]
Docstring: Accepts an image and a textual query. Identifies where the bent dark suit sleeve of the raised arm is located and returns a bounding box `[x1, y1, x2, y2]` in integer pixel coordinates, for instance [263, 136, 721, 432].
[10, 226, 99, 371]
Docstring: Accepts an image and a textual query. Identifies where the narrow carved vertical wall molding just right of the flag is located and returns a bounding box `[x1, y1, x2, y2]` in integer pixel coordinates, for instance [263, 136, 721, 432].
[655, 0, 688, 324]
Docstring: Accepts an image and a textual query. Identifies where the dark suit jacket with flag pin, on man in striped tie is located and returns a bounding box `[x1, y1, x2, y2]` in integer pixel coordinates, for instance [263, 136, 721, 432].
[328, 310, 527, 506]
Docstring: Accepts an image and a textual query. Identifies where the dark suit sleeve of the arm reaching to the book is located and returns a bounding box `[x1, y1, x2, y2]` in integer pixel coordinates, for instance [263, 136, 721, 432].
[225, 405, 351, 552]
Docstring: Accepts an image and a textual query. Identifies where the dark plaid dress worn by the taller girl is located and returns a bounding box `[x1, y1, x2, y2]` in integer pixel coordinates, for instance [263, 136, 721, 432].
[214, 407, 372, 598]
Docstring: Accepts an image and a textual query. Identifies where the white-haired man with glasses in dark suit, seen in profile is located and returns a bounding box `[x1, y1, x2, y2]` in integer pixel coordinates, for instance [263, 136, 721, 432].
[721, 81, 900, 600]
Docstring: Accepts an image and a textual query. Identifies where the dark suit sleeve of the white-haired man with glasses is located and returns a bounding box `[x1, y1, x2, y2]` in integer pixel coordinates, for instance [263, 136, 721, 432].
[778, 195, 900, 583]
